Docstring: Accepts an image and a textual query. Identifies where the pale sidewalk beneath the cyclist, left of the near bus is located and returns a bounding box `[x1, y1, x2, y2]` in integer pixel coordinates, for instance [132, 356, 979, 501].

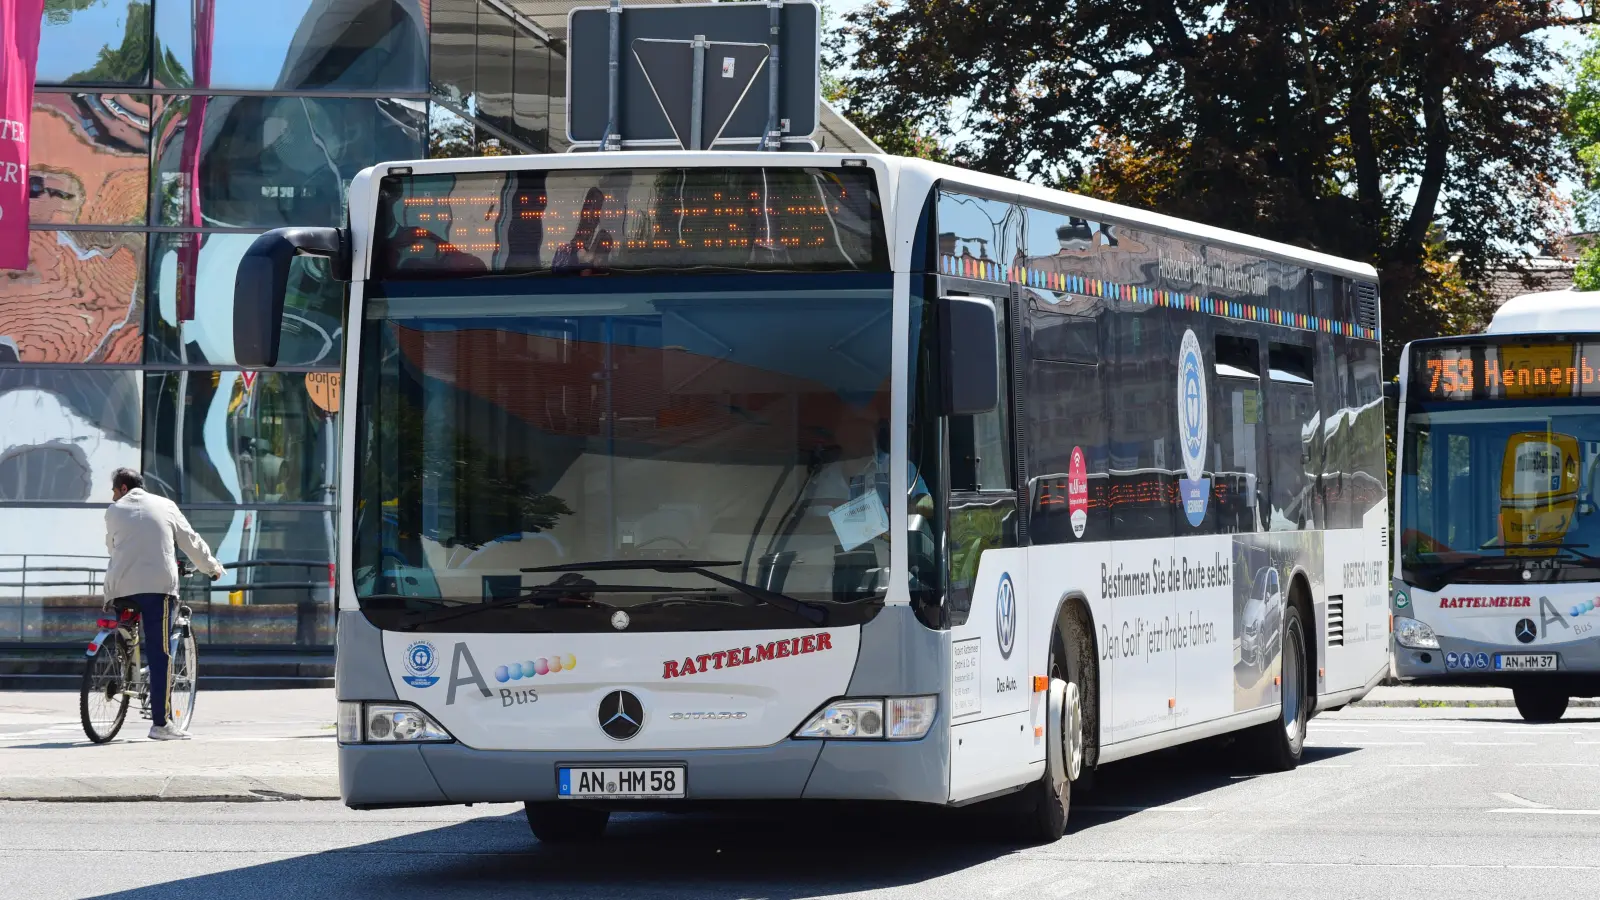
[0, 689, 339, 802]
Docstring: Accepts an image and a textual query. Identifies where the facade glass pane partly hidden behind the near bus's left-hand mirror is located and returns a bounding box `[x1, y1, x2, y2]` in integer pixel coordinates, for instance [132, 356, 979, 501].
[144, 234, 344, 365]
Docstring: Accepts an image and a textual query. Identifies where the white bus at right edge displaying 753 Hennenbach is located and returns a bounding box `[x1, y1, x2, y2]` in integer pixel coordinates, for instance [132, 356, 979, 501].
[1394, 291, 1600, 722]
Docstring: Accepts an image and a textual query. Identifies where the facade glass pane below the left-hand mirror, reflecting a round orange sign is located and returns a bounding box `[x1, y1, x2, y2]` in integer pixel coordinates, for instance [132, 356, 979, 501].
[144, 365, 339, 506]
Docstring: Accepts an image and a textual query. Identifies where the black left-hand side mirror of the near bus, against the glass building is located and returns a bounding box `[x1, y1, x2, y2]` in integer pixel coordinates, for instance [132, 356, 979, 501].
[234, 227, 350, 368]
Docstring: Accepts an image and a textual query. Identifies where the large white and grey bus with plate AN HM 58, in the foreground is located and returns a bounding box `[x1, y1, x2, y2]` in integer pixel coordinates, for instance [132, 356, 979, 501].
[235, 152, 1387, 841]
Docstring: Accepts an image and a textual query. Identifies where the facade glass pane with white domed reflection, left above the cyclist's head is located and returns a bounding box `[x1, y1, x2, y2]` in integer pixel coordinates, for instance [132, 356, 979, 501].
[0, 368, 141, 506]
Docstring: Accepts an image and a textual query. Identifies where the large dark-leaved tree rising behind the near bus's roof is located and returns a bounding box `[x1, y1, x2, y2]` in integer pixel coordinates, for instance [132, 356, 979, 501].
[837, 0, 1590, 359]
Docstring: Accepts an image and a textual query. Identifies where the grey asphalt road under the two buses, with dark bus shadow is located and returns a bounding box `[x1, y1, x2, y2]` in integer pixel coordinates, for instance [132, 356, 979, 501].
[0, 708, 1600, 900]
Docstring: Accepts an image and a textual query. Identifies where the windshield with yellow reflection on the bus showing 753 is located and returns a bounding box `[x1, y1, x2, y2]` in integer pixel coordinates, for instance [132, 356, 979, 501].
[1400, 400, 1600, 589]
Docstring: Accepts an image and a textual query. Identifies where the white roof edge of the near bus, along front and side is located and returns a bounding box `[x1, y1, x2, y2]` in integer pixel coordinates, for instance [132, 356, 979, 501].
[350, 151, 1378, 282]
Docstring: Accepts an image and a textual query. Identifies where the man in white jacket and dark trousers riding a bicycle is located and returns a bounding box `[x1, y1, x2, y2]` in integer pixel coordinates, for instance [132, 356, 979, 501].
[106, 469, 226, 740]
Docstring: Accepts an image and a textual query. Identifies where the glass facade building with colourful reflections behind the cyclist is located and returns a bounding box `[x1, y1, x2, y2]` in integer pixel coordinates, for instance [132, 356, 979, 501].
[0, 0, 565, 649]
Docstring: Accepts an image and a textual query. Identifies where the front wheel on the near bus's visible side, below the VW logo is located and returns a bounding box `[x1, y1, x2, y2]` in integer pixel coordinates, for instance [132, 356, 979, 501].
[1018, 615, 1093, 844]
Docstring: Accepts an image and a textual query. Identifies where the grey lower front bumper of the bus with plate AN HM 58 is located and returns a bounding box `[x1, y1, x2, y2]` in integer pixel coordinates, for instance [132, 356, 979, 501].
[339, 729, 949, 809]
